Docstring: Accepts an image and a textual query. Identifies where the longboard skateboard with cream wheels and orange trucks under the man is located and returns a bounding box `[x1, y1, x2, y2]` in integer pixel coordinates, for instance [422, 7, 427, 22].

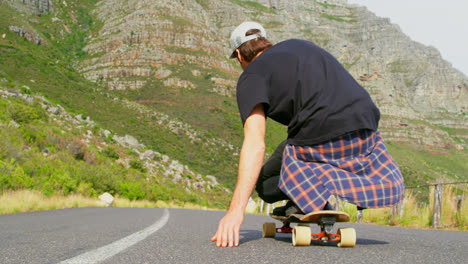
[263, 211, 356, 247]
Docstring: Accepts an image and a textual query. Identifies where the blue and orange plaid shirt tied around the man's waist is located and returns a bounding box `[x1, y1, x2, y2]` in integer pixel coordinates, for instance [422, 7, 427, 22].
[278, 130, 405, 213]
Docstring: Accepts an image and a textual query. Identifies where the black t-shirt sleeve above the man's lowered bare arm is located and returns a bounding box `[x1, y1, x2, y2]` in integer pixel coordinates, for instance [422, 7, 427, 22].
[237, 72, 270, 125]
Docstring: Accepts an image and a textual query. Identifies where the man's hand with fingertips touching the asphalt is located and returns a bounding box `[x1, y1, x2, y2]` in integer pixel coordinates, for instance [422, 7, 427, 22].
[211, 211, 244, 247]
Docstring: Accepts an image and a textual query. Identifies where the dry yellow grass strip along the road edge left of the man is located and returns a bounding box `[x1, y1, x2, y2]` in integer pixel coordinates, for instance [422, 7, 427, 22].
[0, 190, 218, 214]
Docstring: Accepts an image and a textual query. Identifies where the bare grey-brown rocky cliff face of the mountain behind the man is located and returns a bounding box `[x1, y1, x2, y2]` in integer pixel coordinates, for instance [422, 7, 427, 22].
[78, 0, 468, 148]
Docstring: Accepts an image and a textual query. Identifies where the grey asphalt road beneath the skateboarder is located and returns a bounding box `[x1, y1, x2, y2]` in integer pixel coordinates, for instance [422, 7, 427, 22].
[0, 208, 468, 264]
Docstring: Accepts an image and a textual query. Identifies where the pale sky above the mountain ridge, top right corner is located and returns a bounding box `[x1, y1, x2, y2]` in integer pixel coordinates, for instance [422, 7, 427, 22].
[348, 0, 468, 76]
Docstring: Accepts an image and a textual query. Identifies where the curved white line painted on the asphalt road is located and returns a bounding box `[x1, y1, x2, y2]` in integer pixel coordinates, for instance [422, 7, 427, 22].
[59, 208, 169, 264]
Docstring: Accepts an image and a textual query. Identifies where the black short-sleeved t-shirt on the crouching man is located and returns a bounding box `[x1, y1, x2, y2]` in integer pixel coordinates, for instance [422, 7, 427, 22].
[237, 39, 380, 146]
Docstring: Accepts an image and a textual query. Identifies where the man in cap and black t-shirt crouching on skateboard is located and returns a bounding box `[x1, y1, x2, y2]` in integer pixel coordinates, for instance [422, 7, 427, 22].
[211, 22, 404, 247]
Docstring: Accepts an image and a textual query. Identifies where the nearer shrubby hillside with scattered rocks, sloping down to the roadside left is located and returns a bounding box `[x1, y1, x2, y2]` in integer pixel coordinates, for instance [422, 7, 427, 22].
[0, 82, 229, 207]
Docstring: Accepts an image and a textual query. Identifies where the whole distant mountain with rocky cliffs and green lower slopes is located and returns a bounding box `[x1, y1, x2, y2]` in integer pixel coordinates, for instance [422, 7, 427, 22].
[0, 0, 468, 204]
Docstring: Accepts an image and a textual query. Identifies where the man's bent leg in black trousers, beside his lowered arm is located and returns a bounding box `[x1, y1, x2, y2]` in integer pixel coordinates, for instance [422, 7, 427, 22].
[255, 140, 289, 203]
